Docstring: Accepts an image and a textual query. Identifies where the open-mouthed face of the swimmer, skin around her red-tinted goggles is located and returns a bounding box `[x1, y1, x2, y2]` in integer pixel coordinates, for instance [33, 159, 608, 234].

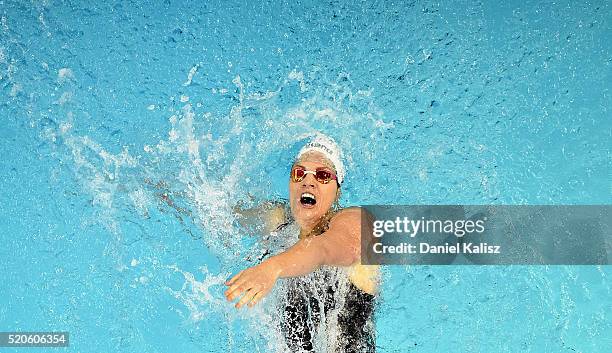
[289, 152, 339, 230]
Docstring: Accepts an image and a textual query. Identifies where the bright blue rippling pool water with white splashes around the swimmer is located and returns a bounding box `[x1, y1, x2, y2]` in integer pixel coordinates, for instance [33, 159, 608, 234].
[0, 0, 612, 352]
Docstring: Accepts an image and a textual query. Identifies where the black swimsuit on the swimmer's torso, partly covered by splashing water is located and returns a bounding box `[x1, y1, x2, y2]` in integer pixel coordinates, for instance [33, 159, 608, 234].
[272, 221, 376, 353]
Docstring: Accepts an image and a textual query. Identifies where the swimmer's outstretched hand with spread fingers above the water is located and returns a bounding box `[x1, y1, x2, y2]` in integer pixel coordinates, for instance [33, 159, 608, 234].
[225, 258, 280, 308]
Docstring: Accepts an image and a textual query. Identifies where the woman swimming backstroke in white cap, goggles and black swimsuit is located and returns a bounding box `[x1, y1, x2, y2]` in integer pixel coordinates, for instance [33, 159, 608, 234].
[225, 135, 378, 352]
